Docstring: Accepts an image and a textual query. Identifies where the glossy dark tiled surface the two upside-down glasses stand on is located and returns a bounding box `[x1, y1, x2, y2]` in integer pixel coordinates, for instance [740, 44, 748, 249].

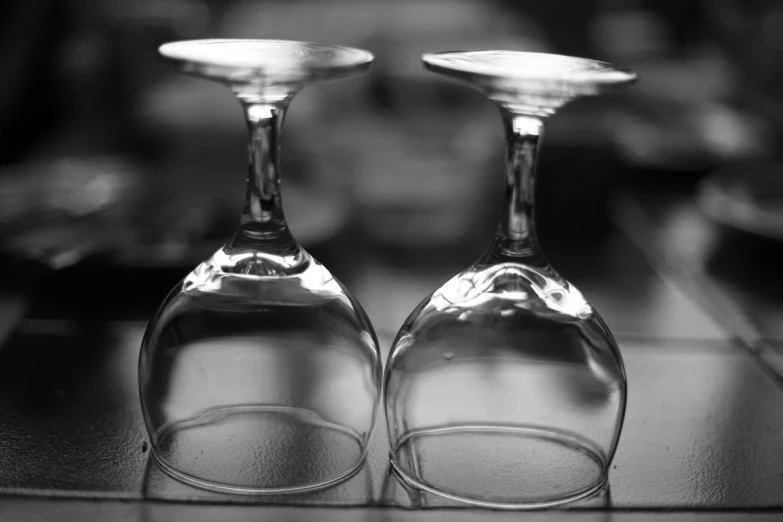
[0, 193, 783, 521]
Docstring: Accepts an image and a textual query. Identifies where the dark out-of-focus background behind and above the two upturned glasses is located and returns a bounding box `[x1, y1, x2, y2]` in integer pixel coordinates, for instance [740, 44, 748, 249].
[0, 0, 783, 338]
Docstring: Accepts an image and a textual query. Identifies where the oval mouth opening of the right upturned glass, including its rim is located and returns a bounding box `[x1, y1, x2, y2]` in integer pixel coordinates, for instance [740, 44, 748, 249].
[391, 424, 607, 509]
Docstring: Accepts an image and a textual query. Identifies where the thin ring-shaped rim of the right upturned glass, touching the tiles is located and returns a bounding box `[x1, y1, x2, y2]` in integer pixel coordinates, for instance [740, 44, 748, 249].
[389, 423, 611, 510]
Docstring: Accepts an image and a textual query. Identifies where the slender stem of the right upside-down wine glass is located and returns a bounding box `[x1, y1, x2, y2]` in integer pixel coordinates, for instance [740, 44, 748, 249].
[491, 109, 544, 258]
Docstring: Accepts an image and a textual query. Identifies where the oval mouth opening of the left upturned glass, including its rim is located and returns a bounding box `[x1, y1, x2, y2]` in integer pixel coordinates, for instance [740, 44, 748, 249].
[153, 405, 366, 495]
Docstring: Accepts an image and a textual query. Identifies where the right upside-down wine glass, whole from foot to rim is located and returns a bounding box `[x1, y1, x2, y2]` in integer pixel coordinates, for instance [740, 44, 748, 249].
[384, 51, 635, 508]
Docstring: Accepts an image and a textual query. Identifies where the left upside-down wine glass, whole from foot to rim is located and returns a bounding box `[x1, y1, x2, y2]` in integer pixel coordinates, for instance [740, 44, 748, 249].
[139, 40, 381, 494]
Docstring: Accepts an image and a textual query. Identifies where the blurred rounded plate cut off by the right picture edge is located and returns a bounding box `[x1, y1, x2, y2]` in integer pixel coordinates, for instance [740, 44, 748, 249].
[696, 163, 783, 241]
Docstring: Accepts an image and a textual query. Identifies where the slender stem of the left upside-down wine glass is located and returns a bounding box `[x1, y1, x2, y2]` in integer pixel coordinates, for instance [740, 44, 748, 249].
[229, 100, 295, 253]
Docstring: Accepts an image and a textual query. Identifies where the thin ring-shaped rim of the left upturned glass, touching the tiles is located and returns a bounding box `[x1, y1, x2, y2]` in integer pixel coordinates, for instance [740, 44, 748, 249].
[150, 405, 369, 497]
